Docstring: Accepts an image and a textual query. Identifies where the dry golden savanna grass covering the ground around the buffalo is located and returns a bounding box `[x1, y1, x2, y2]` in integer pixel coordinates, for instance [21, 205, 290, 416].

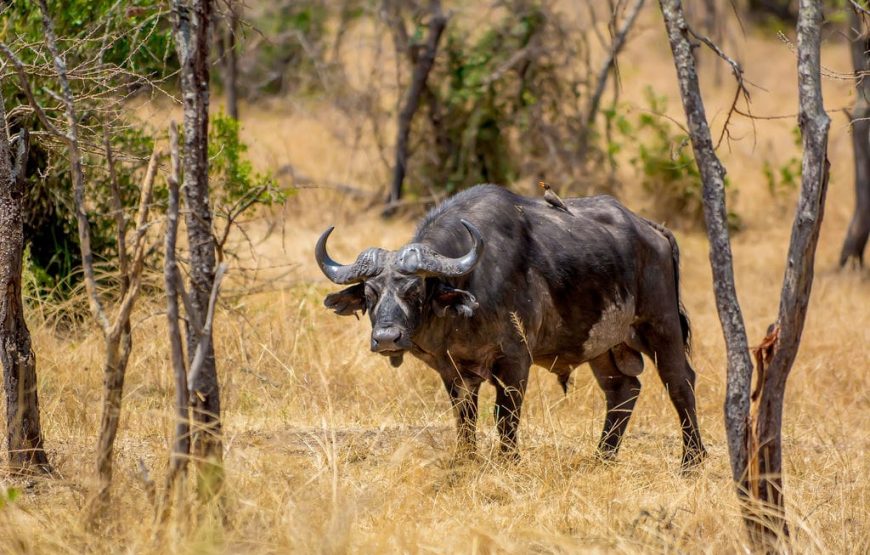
[0, 5, 870, 553]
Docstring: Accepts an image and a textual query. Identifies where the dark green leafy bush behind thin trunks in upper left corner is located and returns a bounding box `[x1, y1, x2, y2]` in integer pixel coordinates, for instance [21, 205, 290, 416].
[0, 0, 177, 295]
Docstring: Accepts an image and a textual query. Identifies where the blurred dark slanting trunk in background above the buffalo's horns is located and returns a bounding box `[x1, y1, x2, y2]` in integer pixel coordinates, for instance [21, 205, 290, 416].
[384, 0, 447, 214]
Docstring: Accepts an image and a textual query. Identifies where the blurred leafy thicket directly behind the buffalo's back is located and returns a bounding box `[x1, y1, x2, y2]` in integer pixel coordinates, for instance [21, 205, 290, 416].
[407, 0, 604, 195]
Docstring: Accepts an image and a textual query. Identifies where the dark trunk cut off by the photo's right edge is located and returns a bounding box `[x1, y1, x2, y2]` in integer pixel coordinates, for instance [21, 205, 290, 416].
[840, 5, 870, 267]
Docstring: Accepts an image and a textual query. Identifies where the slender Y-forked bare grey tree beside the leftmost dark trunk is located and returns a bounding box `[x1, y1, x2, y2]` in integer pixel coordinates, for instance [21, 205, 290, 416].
[33, 0, 160, 519]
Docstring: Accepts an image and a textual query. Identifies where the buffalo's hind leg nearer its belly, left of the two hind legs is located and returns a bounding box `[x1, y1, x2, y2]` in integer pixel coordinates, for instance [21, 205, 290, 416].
[589, 351, 640, 459]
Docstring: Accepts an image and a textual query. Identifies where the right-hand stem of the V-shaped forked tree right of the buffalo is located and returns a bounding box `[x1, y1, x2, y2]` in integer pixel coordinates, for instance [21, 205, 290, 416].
[747, 0, 831, 549]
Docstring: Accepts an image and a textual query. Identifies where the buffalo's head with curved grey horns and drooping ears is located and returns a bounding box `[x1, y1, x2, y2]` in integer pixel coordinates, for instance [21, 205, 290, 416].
[315, 220, 483, 366]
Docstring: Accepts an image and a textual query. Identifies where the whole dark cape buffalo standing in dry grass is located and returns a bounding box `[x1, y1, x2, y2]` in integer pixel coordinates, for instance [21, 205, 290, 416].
[316, 185, 706, 467]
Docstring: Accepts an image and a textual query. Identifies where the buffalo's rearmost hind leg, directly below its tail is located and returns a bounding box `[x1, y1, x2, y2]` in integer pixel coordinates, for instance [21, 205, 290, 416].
[641, 322, 707, 470]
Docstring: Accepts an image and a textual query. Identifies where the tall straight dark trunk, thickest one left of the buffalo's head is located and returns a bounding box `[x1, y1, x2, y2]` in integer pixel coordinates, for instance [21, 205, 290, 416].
[172, 0, 223, 496]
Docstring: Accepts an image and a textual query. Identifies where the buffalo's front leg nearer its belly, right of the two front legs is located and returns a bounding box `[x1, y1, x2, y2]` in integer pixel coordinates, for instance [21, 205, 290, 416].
[493, 360, 529, 459]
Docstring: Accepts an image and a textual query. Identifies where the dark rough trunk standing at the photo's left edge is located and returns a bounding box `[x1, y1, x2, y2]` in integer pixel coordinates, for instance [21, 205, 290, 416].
[0, 99, 51, 474]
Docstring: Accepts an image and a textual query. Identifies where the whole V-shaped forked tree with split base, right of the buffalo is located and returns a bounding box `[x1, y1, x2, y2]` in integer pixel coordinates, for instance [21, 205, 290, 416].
[660, 0, 830, 550]
